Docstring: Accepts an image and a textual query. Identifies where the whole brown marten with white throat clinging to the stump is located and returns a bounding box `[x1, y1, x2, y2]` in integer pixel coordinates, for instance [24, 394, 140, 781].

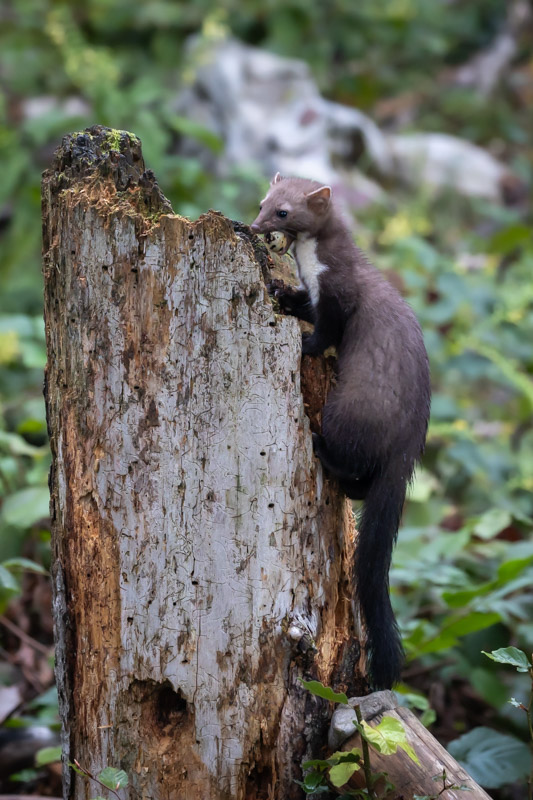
[252, 173, 430, 688]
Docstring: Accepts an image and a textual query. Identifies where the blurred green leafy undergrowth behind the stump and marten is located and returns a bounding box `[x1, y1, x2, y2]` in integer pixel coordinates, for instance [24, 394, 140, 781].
[0, 0, 533, 798]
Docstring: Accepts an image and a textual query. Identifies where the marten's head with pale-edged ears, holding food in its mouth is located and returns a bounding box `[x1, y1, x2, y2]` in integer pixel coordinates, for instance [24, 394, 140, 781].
[251, 172, 331, 252]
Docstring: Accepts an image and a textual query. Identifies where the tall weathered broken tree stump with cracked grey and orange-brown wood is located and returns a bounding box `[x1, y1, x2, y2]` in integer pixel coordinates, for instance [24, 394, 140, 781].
[43, 128, 362, 800]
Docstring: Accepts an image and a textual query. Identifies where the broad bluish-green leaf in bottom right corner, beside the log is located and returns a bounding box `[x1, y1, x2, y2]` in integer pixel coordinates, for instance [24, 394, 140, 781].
[448, 727, 530, 789]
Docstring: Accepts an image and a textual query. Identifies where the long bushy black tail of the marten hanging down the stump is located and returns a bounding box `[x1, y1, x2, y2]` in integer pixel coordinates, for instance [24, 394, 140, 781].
[355, 464, 406, 689]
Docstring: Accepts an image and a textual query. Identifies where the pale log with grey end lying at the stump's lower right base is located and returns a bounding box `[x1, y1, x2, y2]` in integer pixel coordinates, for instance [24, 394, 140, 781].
[329, 692, 491, 800]
